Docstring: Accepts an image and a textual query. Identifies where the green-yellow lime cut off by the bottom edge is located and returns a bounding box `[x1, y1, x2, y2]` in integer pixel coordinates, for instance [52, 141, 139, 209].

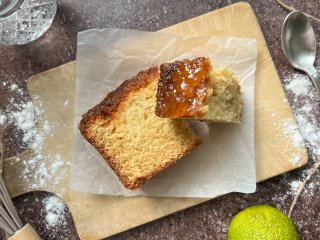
[228, 205, 299, 240]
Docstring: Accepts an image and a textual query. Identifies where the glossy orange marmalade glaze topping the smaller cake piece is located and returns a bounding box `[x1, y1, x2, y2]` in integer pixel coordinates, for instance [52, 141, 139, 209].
[156, 57, 212, 118]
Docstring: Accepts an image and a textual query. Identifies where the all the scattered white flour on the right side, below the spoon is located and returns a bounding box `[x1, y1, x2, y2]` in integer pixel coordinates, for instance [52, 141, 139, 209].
[283, 73, 320, 196]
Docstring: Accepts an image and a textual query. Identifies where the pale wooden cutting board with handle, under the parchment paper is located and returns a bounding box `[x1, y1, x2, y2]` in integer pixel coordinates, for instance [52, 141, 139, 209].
[28, 3, 308, 239]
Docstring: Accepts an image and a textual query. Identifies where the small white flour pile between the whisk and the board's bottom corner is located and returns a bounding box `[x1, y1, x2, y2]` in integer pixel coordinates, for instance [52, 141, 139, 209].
[43, 196, 66, 228]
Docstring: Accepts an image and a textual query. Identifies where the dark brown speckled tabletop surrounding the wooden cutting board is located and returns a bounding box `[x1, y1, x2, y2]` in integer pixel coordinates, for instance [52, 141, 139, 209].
[0, 0, 320, 240]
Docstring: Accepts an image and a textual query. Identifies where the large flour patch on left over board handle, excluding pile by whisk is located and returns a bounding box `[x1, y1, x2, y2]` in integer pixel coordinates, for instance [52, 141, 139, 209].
[0, 84, 65, 190]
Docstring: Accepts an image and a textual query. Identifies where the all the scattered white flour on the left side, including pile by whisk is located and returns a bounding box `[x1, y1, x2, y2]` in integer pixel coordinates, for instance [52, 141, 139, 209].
[0, 81, 69, 232]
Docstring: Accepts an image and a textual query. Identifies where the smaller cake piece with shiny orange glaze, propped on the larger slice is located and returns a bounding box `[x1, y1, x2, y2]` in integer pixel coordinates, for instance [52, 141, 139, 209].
[155, 57, 243, 123]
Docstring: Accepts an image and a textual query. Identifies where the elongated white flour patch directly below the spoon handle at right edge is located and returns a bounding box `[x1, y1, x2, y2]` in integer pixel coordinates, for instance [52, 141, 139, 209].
[284, 73, 320, 157]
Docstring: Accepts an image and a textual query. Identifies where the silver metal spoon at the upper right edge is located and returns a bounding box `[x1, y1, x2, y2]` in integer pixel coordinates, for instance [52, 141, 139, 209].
[281, 12, 320, 90]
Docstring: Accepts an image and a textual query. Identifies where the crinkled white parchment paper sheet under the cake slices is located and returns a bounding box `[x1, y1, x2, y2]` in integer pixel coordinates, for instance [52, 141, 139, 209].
[70, 29, 257, 198]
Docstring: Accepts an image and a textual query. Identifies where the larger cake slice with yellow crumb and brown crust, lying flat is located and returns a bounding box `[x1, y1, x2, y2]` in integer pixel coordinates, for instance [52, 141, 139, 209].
[79, 67, 200, 189]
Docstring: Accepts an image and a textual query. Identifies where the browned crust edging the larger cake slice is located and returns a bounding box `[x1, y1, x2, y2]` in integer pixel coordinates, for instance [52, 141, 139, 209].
[79, 67, 201, 190]
